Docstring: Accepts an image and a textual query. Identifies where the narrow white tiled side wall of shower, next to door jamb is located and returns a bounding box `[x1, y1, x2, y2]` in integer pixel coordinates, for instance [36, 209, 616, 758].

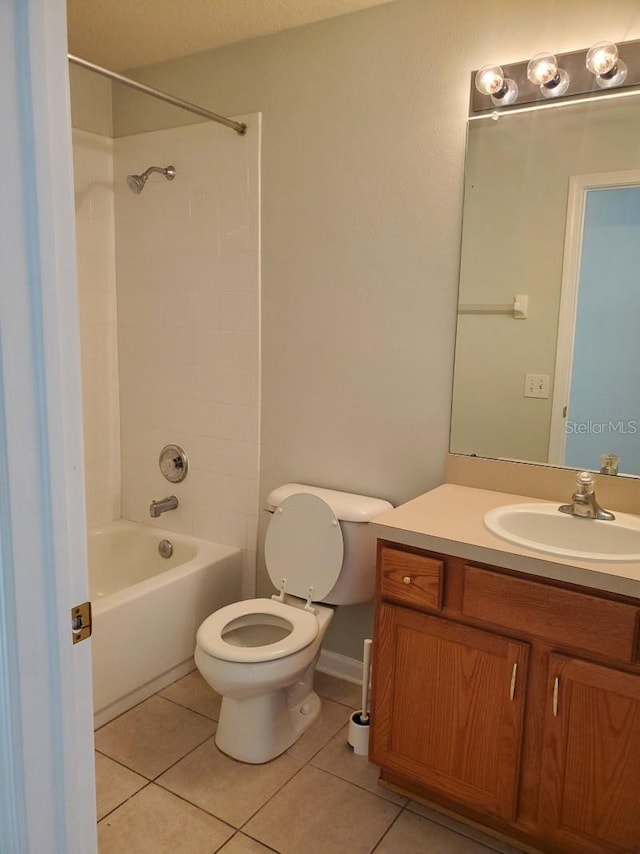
[73, 129, 120, 528]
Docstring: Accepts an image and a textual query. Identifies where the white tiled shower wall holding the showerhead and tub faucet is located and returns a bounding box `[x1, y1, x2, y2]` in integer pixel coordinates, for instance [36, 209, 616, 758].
[114, 114, 260, 595]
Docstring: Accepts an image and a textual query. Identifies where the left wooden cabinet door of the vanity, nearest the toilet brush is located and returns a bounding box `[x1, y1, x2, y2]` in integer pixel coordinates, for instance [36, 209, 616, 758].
[371, 605, 528, 820]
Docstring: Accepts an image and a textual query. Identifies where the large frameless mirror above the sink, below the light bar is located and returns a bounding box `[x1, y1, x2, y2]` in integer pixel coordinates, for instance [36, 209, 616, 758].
[450, 94, 640, 482]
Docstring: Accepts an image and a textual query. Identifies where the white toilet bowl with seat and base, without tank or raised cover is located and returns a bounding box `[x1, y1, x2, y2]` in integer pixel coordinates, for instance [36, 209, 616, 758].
[195, 598, 333, 764]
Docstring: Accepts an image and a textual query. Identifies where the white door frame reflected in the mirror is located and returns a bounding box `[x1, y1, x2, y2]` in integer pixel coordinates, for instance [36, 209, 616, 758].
[548, 169, 640, 466]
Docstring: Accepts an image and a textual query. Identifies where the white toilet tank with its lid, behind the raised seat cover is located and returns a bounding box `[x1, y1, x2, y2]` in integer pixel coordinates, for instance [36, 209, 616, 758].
[266, 483, 393, 605]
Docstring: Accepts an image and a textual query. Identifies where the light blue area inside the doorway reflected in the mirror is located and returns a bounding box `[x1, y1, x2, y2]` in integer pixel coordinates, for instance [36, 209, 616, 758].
[565, 186, 640, 474]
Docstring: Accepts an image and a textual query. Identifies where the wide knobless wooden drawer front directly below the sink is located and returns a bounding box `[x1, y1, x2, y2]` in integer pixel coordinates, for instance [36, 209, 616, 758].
[462, 566, 639, 662]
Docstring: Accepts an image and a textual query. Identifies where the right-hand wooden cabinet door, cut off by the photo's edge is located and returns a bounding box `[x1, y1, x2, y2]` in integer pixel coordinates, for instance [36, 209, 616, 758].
[540, 655, 640, 854]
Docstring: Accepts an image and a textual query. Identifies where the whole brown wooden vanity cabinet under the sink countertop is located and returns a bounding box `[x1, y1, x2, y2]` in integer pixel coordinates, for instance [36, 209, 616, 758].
[370, 541, 640, 854]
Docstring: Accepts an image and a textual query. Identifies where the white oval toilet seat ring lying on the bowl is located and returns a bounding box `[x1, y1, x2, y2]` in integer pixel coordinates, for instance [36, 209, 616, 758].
[196, 599, 318, 663]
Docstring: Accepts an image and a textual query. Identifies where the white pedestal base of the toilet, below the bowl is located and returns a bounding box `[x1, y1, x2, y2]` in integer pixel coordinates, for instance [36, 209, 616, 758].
[215, 682, 321, 765]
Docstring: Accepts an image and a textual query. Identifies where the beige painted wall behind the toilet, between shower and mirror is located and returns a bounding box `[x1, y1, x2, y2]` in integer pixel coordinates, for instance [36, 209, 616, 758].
[105, 0, 640, 656]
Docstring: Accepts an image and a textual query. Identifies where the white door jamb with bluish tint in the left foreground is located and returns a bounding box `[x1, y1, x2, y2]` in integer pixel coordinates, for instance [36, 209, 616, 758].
[0, 0, 96, 854]
